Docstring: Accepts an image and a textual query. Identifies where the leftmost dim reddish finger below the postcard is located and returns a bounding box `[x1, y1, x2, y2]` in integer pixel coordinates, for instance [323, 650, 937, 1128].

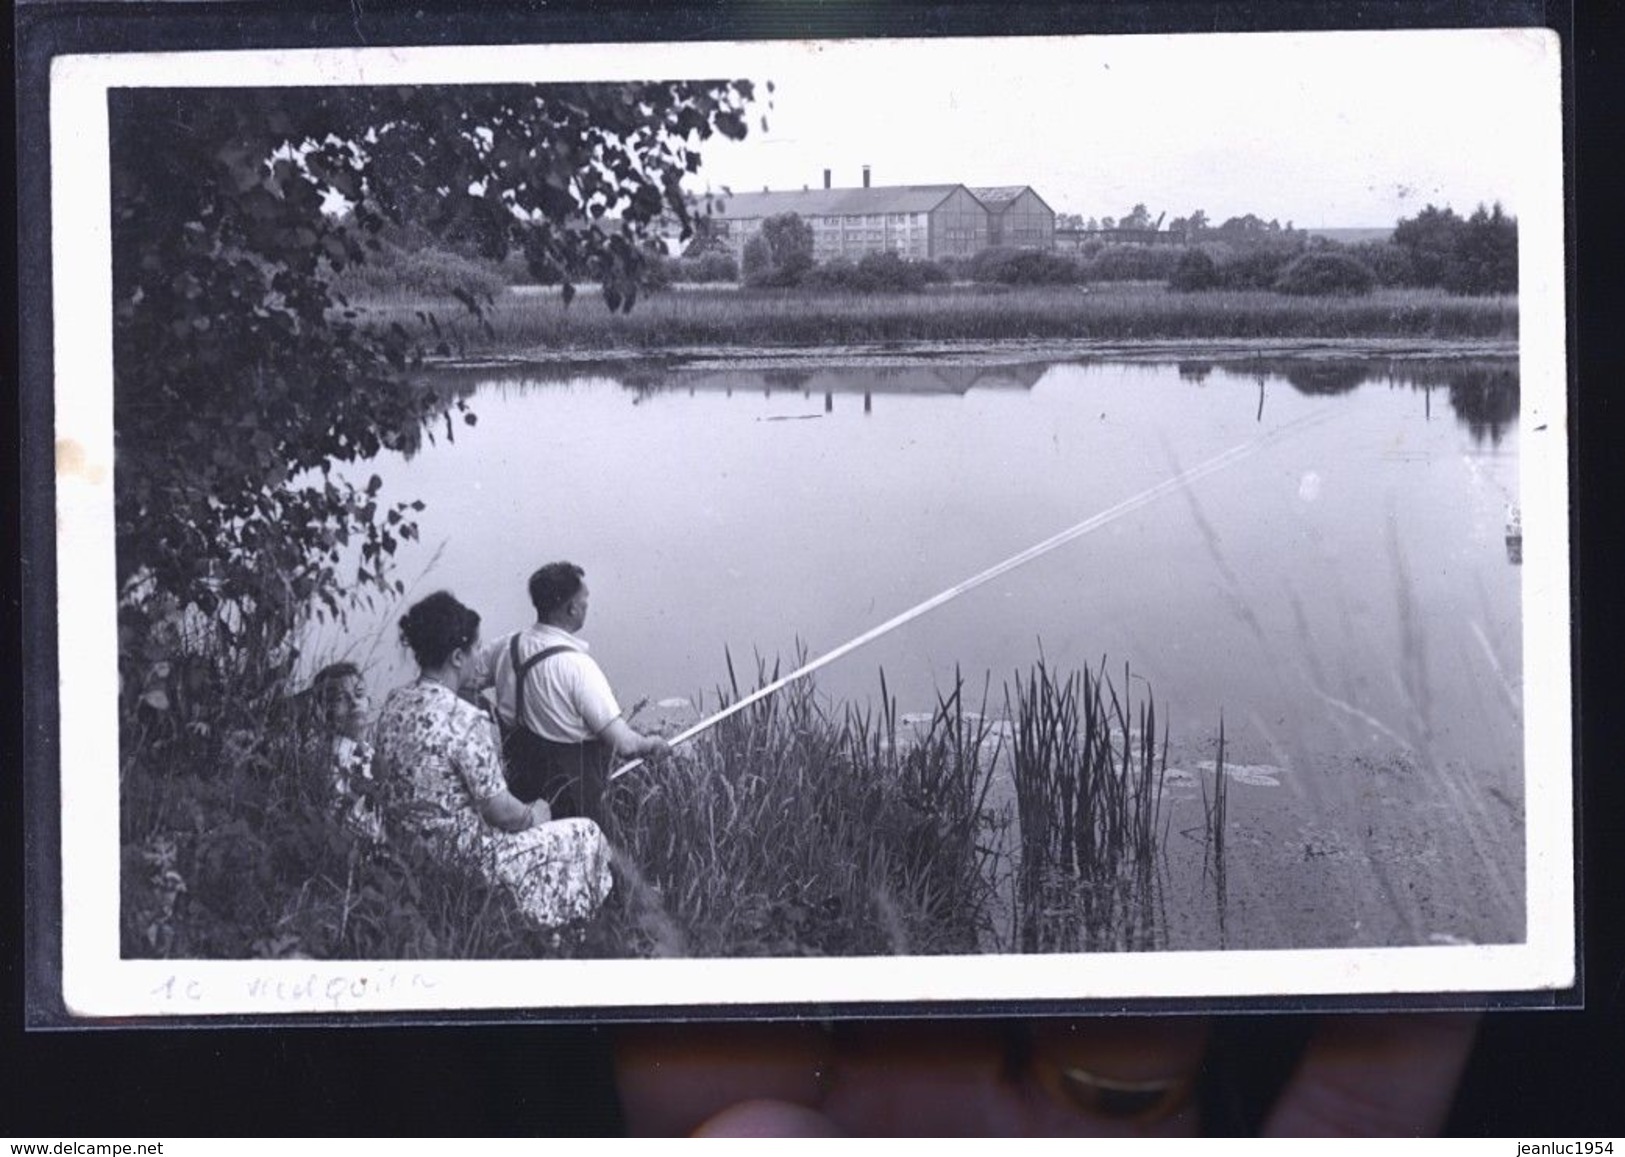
[614, 1024, 830, 1136]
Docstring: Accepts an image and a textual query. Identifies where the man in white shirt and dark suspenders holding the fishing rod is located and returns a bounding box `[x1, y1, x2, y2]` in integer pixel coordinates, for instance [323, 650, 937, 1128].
[470, 562, 670, 822]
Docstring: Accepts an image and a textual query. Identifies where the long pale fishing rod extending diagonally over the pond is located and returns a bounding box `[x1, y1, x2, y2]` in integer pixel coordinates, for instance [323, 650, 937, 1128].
[609, 410, 1329, 780]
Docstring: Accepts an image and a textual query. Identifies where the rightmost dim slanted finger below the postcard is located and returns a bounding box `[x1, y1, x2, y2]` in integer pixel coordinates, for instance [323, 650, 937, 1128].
[1264, 1014, 1477, 1138]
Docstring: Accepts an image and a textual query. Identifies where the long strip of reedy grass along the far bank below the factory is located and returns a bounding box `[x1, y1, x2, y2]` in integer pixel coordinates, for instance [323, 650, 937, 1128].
[346, 283, 1518, 356]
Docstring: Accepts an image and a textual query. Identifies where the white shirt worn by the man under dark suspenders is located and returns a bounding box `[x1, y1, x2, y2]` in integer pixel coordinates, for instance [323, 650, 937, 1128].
[471, 622, 621, 743]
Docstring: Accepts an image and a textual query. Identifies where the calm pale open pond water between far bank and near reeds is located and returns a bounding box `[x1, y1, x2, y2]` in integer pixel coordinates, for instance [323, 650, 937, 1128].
[322, 359, 1521, 786]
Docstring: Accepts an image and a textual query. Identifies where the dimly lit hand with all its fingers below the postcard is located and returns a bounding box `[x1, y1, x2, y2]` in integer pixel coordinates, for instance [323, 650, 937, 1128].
[616, 1014, 1476, 1136]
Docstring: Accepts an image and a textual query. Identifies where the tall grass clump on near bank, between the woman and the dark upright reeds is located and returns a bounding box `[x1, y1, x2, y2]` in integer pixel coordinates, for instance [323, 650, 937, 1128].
[609, 657, 999, 956]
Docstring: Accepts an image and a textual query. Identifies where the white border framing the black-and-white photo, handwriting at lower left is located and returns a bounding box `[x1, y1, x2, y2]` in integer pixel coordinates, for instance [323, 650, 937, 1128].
[50, 28, 1578, 1017]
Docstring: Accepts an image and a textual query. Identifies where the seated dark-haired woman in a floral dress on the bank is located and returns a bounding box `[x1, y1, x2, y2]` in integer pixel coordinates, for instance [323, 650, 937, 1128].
[372, 590, 613, 928]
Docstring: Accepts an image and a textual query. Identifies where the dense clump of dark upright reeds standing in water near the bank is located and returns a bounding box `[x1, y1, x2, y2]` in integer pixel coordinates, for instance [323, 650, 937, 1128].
[1006, 661, 1168, 952]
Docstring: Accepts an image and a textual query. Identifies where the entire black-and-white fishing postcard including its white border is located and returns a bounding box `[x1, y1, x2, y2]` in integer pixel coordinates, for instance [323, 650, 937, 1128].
[49, 29, 1576, 1019]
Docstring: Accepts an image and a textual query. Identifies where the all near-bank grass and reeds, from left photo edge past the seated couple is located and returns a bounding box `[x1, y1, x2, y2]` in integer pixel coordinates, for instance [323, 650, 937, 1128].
[120, 633, 1189, 959]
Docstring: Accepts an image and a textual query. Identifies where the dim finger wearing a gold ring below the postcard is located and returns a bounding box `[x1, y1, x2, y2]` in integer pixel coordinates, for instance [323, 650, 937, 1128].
[1027, 1017, 1207, 1136]
